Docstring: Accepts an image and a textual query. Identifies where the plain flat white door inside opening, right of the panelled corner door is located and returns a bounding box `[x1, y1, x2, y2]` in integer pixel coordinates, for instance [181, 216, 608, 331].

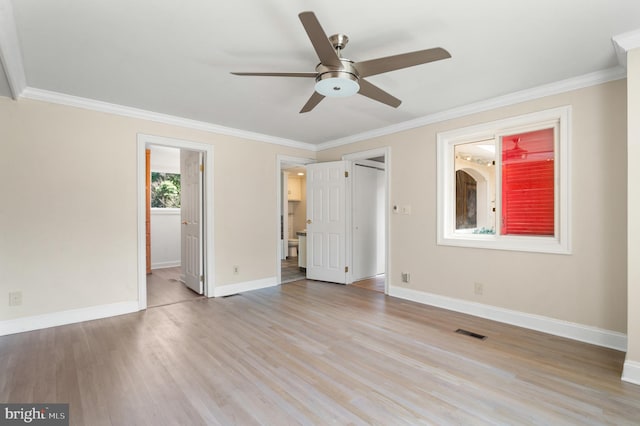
[352, 164, 385, 281]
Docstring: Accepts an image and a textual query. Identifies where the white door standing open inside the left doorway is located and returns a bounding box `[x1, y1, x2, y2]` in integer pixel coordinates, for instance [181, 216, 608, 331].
[180, 149, 203, 294]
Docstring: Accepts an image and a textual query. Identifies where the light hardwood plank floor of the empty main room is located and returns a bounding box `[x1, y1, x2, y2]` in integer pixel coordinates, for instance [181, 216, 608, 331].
[0, 281, 640, 425]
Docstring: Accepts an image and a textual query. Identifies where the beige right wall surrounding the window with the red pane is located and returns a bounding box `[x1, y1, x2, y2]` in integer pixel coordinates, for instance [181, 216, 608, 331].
[318, 80, 627, 333]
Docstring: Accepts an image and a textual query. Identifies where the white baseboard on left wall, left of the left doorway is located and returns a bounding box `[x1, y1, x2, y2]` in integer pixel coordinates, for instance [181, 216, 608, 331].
[0, 300, 138, 336]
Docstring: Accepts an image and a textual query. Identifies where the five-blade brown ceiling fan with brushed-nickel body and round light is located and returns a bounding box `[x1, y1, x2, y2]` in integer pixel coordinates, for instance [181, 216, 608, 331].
[231, 12, 451, 113]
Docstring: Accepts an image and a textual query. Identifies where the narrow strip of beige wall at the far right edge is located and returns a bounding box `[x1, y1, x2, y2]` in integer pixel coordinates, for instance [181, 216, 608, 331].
[626, 49, 640, 362]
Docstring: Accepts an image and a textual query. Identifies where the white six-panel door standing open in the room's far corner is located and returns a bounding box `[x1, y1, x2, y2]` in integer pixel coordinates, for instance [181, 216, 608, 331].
[307, 161, 348, 284]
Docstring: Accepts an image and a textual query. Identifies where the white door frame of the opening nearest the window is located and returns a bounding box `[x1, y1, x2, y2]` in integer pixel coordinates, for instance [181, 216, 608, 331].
[342, 146, 391, 294]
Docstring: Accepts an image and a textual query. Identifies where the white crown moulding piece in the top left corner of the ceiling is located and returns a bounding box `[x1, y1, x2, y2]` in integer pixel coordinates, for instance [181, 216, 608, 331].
[0, 0, 27, 99]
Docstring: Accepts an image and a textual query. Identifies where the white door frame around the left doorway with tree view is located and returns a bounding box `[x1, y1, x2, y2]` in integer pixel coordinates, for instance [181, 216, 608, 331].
[137, 133, 215, 310]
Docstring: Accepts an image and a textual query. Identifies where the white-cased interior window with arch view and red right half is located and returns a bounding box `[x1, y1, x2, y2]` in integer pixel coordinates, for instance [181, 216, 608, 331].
[437, 106, 571, 254]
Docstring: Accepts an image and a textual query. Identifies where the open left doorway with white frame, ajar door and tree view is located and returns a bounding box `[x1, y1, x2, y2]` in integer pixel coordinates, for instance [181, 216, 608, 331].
[138, 135, 213, 309]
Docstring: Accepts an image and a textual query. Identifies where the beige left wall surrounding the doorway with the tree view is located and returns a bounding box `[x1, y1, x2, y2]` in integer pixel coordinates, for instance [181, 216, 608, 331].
[0, 97, 314, 321]
